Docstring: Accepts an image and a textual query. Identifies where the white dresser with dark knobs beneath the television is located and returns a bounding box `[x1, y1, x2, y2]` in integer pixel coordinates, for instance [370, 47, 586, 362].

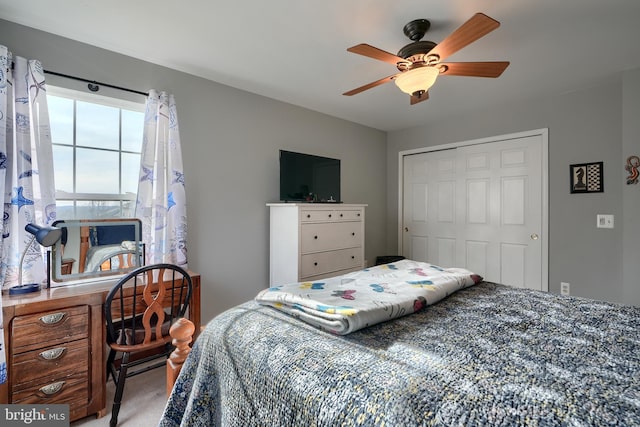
[267, 203, 367, 286]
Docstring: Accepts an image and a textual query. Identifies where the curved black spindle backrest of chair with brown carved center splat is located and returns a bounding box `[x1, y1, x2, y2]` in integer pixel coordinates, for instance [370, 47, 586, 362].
[104, 264, 193, 347]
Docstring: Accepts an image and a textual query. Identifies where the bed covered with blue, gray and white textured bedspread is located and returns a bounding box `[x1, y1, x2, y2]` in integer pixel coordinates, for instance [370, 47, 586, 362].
[160, 260, 640, 426]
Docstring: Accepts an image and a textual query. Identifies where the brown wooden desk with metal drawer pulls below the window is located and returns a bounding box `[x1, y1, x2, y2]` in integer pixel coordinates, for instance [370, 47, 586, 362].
[0, 273, 200, 421]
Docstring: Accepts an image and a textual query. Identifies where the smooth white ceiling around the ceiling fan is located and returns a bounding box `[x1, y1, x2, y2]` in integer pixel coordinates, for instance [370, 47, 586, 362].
[0, 0, 640, 130]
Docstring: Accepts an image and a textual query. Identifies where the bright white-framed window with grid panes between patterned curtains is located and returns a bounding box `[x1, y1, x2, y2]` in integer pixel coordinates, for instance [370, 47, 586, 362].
[47, 86, 145, 219]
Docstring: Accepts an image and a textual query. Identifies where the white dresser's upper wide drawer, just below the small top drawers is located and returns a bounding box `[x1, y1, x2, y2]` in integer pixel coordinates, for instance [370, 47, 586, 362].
[300, 222, 363, 254]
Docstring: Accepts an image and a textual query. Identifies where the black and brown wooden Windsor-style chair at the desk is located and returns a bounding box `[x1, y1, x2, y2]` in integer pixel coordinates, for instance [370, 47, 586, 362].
[104, 264, 192, 427]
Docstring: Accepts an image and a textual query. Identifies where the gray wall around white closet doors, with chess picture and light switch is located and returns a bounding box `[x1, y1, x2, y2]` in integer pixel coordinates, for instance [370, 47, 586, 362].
[387, 71, 640, 305]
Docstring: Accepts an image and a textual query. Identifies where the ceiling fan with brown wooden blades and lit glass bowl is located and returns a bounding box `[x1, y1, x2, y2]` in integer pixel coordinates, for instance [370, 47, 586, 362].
[343, 13, 509, 105]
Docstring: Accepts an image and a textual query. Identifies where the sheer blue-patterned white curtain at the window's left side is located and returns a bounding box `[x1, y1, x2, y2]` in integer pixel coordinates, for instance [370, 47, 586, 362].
[0, 45, 56, 382]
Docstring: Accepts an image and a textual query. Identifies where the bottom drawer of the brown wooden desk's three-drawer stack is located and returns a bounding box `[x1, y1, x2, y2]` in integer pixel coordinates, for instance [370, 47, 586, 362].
[11, 373, 89, 411]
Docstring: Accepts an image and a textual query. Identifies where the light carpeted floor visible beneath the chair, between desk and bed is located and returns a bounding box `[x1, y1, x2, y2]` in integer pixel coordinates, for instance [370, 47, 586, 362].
[71, 368, 167, 427]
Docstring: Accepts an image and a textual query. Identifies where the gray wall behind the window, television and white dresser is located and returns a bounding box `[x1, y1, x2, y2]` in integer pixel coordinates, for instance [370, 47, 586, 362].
[0, 20, 386, 321]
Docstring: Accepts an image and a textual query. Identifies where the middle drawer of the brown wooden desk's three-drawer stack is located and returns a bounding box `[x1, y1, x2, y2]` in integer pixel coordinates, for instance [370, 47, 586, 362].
[11, 338, 90, 387]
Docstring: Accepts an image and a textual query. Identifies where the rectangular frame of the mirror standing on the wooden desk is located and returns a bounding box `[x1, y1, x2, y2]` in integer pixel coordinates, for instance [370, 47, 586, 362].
[50, 218, 145, 286]
